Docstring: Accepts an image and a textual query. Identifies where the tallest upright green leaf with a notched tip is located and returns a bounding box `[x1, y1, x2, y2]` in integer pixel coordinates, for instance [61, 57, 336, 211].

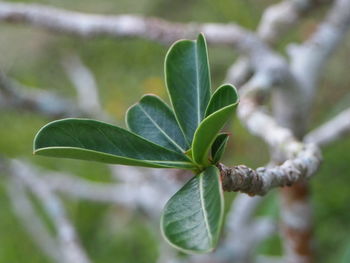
[165, 34, 211, 143]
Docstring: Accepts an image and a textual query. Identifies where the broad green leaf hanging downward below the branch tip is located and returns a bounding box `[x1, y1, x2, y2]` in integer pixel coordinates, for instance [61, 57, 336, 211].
[161, 166, 224, 253]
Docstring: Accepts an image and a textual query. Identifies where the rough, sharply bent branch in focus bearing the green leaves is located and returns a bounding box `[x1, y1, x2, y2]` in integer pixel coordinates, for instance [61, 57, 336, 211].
[219, 72, 322, 195]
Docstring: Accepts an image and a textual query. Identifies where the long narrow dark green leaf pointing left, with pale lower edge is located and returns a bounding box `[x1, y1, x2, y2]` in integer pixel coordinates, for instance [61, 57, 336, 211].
[34, 119, 195, 169]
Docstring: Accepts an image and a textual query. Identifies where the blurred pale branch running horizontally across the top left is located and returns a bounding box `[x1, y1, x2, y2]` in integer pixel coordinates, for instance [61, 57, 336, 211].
[0, 2, 258, 46]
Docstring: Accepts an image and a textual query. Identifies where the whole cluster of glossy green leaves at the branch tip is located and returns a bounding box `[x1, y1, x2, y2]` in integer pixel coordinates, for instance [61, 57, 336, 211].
[34, 34, 238, 252]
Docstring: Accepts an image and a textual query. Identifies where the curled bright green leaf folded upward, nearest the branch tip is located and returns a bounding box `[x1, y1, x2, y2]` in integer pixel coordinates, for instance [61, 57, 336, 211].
[192, 84, 238, 166]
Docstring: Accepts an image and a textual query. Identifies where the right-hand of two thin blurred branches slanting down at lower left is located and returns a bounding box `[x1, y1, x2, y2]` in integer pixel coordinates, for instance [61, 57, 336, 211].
[9, 160, 91, 263]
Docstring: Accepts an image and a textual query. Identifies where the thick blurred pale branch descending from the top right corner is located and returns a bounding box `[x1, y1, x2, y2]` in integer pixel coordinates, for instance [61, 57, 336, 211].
[273, 0, 350, 139]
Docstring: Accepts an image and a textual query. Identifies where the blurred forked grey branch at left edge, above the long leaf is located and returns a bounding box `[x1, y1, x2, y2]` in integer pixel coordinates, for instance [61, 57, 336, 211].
[0, 55, 112, 121]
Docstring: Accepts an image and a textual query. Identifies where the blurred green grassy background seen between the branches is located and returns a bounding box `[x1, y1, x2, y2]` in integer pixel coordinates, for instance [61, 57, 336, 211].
[0, 0, 350, 263]
